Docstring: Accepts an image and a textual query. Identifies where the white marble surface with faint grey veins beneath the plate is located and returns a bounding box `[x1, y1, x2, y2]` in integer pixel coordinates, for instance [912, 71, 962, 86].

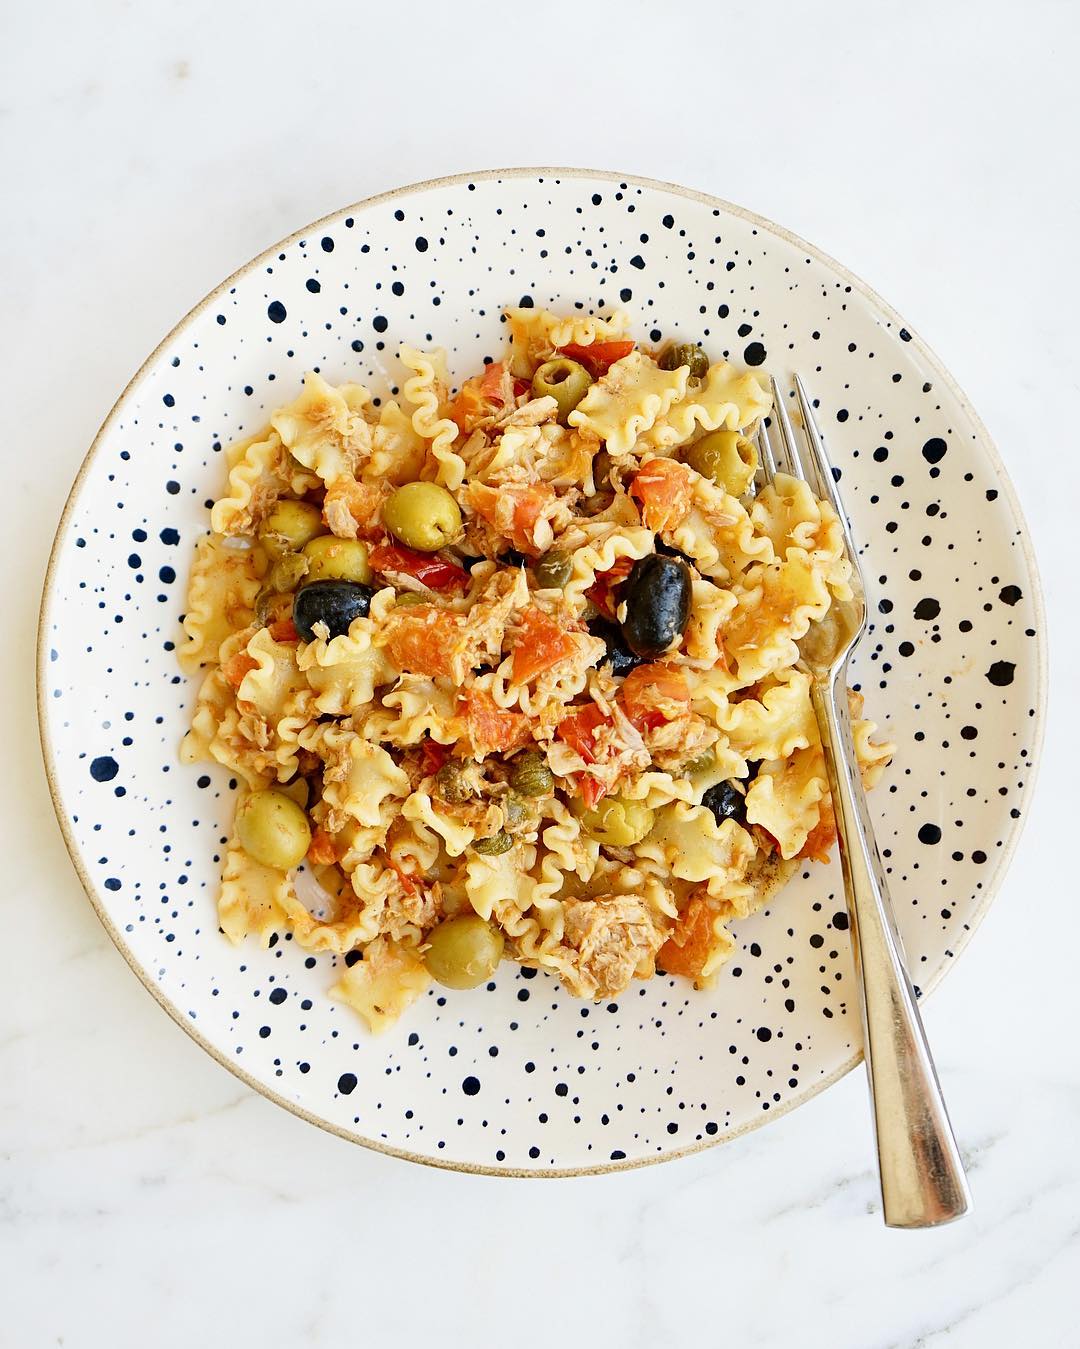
[0, 0, 1080, 1349]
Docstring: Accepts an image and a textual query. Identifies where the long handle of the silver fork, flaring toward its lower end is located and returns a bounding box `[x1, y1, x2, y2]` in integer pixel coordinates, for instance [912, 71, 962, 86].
[810, 670, 971, 1228]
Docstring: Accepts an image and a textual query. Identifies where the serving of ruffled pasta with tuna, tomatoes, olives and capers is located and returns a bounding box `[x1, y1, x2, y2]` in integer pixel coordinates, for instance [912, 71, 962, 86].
[178, 308, 893, 1031]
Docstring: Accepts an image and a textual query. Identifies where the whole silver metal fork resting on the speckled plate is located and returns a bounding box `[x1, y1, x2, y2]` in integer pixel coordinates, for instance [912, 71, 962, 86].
[758, 375, 971, 1228]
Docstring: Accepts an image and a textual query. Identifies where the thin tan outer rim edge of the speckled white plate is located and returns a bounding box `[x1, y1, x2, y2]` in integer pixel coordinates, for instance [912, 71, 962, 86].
[35, 166, 1049, 1179]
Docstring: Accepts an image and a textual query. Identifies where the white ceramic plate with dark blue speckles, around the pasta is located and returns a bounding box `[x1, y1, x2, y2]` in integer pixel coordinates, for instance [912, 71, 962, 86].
[39, 170, 1045, 1175]
